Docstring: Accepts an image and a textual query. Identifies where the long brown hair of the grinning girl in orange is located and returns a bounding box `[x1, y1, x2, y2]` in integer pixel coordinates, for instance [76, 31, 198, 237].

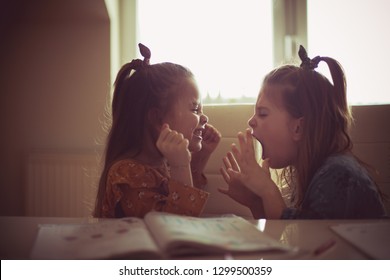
[94, 62, 193, 217]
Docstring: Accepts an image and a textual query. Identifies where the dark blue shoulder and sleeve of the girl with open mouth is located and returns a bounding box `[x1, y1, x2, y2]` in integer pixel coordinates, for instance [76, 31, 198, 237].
[305, 154, 385, 219]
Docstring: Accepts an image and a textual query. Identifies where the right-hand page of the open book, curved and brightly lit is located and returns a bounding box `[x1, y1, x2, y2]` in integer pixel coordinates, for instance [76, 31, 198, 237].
[145, 212, 289, 255]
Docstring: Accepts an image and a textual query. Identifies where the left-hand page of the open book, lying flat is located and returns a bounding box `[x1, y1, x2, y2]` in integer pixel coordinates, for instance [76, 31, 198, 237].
[31, 218, 159, 259]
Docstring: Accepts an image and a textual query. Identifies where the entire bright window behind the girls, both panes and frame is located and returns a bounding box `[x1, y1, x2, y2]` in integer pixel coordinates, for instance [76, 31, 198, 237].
[105, 0, 390, 105]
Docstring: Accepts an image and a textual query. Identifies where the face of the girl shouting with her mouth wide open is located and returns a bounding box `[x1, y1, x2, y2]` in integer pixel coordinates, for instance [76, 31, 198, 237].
[248, 86, 302, 168]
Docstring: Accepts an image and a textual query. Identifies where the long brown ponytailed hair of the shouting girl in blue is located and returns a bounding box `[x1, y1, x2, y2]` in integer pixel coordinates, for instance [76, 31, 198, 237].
[263, 57, 352, 207]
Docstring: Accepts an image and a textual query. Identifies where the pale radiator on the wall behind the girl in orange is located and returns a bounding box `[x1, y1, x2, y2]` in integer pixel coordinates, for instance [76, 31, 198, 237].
[25, 153, 99, 217]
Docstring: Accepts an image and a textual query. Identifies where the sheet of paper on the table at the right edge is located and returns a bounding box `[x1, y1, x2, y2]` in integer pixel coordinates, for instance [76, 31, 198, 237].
[331, 222, 390, 259]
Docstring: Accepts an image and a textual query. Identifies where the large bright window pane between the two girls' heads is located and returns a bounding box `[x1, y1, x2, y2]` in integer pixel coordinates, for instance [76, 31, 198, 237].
[137, 0, 273, 103]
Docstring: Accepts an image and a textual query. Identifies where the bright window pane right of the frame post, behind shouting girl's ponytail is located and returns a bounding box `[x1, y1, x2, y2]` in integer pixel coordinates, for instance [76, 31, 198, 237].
[307, 0, 390, 105]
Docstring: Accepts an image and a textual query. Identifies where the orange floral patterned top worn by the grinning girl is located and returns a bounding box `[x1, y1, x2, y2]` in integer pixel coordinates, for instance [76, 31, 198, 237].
[102, 159, 209, 218]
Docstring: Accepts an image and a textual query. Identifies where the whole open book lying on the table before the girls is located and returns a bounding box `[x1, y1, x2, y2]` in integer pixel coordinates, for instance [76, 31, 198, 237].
[31, 212, 290, 259]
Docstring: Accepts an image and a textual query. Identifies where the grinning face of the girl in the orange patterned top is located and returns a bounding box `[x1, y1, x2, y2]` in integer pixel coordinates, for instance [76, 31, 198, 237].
[163, 79, 208, 152]
